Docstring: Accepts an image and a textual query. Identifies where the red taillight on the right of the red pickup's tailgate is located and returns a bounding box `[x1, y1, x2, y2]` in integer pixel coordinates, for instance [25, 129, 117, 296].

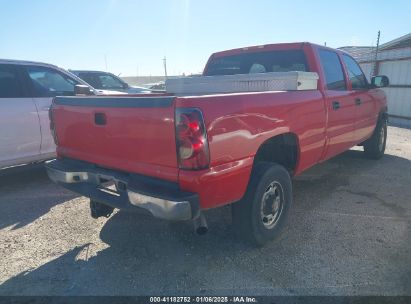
[176, 108, 210, 170]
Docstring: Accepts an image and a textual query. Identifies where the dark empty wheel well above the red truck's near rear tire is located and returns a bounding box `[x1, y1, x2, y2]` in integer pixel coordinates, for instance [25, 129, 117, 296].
[254, 133, 298, 174]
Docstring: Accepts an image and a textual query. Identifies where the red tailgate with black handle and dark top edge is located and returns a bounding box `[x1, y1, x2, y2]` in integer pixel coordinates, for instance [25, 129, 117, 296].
[53, 96, 178, 181]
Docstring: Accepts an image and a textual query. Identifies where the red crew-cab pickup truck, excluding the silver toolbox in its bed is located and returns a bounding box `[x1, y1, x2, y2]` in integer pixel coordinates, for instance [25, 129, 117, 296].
[47, 43, 388, 245]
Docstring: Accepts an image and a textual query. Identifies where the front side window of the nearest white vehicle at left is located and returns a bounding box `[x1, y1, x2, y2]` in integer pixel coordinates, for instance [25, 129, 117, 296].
[26, 66, 78, 97]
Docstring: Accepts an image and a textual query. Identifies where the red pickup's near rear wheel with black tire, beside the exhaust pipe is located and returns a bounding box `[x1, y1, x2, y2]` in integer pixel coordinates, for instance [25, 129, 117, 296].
[232, 162, 292, 246]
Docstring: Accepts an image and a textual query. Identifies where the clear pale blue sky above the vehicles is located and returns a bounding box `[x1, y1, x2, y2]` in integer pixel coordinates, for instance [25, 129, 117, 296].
[0, 0, 411, 76]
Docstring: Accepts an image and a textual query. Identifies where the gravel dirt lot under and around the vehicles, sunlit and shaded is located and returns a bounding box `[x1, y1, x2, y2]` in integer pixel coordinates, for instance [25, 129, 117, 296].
[0, 127, 411, 295]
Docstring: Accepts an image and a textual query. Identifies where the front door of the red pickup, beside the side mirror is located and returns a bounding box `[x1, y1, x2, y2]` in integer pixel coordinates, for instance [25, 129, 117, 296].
[342, 55, 378, 144]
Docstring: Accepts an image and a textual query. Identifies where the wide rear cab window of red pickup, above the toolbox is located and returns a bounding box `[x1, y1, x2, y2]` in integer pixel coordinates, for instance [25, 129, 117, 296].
[204, 50, 308, 76]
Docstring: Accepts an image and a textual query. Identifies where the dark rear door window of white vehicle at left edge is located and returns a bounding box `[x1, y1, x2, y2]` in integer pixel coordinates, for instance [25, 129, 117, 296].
[0, 64, 24, 98]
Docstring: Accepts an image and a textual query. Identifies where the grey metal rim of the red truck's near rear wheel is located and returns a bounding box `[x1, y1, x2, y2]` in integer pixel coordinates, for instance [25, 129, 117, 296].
[261, 182, 284, 229]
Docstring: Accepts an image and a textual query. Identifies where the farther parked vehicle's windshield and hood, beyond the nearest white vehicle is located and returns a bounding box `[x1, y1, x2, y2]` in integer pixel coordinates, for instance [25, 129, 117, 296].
[70, 70, 151, 94]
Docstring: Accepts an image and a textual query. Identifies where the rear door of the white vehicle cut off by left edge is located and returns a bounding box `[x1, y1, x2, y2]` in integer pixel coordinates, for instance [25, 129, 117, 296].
[0, 64, 41, 167]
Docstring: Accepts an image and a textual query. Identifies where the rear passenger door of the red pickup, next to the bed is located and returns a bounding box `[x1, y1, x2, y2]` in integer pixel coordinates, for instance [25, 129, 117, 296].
[318, 48, 355, 159]
